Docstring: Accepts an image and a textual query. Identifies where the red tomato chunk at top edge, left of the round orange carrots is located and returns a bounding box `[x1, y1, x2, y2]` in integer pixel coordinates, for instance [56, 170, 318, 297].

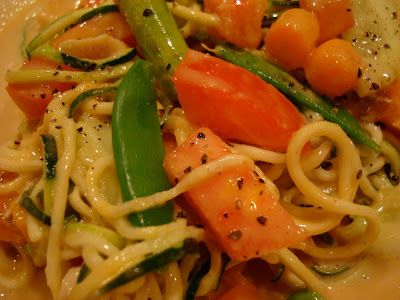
[204, 0, 267, 48]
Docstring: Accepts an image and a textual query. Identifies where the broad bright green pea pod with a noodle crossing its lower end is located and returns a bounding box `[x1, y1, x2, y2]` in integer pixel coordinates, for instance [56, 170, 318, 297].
[112, 60, 173, 226]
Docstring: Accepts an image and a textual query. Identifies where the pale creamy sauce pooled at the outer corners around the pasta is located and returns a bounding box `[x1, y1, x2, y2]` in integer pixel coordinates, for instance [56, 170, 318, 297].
[0, 0, 400, 300]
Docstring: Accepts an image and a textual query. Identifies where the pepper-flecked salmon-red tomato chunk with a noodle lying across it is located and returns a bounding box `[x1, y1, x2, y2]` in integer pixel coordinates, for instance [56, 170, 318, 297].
[164, 128, 310, 260]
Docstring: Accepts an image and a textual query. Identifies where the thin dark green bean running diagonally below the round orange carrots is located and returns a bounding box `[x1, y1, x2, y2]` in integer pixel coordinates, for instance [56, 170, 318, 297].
[215, 46, 380, 152]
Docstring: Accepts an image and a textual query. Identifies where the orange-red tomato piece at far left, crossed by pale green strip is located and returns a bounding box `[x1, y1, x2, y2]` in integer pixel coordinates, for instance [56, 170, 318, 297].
[6, 56, 76, 120]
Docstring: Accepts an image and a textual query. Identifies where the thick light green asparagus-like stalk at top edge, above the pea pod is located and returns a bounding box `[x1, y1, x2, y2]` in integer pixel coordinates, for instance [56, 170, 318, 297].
[119, 0, 188, 102]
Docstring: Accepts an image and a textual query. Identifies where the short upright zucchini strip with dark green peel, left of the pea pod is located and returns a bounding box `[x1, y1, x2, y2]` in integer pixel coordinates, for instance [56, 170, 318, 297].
[41, 134, 58, 215]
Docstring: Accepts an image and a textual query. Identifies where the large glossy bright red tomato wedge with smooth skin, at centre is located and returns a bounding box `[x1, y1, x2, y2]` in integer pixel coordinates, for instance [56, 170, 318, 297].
[172, 50, 307, 152]
